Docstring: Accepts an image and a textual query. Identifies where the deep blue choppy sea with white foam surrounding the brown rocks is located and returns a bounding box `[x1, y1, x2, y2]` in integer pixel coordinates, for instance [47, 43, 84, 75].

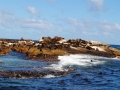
[0, 45, 120, 90]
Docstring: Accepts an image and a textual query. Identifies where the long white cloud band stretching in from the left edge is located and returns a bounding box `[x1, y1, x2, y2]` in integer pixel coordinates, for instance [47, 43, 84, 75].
[0, 12, 53, 30]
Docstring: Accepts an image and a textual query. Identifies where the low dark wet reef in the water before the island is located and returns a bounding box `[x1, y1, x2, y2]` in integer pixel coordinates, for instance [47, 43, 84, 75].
[0, 70, 73, 78]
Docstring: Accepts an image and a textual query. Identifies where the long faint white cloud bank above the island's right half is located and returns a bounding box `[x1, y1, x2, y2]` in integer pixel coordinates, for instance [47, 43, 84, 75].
[66, 18, 120, 31]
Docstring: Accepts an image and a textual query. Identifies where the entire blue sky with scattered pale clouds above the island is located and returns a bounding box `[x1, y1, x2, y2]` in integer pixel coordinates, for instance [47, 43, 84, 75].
[0, 0, 120, 45]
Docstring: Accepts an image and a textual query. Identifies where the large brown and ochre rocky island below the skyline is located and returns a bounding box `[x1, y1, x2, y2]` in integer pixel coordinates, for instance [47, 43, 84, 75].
[0, 36, 120, 62]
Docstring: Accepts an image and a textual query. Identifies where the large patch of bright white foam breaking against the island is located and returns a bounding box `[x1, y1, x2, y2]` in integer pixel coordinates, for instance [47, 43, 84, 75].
[46, 54, 107, 71]
